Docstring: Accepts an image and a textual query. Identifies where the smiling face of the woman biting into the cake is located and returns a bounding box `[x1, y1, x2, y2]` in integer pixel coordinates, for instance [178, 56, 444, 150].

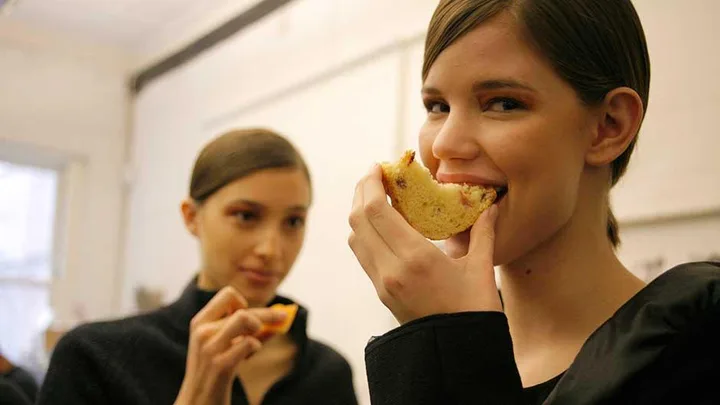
[420, 14, 593, 265]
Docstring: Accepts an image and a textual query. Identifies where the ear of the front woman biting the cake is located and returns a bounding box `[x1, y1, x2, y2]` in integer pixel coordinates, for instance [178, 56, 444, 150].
[585, 87, 644, 166]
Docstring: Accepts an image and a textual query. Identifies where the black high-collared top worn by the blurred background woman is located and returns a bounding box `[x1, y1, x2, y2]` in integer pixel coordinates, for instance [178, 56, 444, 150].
[37, 280, 357, 405]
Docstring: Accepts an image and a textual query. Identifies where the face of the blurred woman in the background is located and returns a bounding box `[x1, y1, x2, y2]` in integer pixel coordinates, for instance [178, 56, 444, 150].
[183, 169, 311, 306]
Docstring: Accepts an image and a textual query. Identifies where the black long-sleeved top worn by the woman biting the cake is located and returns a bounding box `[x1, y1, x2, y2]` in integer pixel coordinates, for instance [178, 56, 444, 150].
[366, 262, 720, 405]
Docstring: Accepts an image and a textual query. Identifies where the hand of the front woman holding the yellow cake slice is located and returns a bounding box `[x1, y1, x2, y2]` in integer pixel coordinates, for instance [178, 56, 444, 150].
[348, 165, 502, 323]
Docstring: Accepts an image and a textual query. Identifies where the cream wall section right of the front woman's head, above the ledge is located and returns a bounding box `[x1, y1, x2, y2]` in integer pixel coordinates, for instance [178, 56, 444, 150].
[613, 0, 720, 221]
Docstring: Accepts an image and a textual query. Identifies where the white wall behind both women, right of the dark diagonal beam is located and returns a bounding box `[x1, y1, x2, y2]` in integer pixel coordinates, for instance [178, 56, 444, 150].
[123, 0, 720, 403]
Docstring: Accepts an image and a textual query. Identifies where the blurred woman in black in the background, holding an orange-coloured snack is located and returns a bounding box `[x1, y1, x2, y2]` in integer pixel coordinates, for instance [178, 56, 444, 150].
[39, 129, 356, 405]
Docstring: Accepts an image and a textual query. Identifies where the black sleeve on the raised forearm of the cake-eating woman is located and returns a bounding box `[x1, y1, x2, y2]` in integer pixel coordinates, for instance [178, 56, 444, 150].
[365, 312, 522, 405]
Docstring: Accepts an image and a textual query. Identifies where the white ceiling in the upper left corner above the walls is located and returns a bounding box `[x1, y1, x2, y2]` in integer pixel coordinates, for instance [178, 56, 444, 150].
[4, 0, 266, 61]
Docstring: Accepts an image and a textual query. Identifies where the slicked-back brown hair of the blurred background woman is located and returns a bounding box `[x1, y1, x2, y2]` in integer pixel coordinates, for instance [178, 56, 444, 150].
[190, 128, 312, 204]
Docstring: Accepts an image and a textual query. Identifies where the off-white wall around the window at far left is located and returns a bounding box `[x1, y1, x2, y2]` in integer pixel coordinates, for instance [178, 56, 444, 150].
[0, 21, 130, 326]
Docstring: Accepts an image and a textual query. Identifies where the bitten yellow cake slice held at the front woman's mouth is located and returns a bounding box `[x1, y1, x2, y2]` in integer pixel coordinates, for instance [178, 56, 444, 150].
[381, 150, 497, 240]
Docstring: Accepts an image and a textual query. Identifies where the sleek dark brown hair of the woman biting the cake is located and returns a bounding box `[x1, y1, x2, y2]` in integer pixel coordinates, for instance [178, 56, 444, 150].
[422, 0, 650, 246]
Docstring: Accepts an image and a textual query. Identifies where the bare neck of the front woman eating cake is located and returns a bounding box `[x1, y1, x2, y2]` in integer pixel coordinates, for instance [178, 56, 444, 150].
[500, 199, 644, 374]
